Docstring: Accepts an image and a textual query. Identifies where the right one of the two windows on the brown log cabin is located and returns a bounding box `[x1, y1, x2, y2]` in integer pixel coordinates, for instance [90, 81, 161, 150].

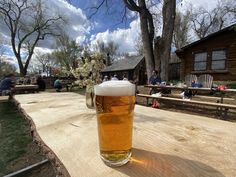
[211, 50, 226, 70]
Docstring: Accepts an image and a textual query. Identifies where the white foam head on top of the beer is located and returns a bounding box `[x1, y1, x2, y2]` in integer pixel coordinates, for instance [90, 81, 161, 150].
[94, 81, 135, 96]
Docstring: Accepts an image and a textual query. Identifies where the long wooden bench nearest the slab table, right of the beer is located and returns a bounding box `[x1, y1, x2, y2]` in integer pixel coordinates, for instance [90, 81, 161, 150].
[137, 94, 236, 117]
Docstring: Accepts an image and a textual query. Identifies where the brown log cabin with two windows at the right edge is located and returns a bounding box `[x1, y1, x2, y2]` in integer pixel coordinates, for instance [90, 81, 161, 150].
[176, 24, 236, 81]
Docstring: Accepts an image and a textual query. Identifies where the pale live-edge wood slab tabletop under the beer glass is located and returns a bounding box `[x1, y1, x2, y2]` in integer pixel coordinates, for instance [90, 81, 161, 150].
[14, 93, 236, 177]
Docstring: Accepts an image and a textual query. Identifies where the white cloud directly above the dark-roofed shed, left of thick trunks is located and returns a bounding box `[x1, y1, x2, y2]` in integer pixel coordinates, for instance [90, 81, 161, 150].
[90, 20, 140, 54]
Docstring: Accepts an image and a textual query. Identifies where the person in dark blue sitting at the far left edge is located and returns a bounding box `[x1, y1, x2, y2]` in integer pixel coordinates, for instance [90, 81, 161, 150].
[0, 74, 15, 96]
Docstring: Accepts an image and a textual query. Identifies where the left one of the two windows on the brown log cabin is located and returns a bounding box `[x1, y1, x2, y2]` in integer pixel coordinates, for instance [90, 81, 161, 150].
[194, 52, 207, 71]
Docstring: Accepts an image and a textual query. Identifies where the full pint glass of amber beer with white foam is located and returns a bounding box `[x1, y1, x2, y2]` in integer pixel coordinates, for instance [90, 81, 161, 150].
[95, 81, 135, 166]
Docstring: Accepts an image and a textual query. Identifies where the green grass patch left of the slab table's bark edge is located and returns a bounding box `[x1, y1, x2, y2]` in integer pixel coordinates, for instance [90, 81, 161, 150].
[0, 102, 32, 176]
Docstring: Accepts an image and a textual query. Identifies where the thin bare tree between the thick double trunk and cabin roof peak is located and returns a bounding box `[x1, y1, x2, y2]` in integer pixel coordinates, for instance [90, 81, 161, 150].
[173, 11, 191, 49]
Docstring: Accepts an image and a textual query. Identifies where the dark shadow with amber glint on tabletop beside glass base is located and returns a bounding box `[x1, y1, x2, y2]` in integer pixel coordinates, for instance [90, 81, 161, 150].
[113, 148, 225, 177]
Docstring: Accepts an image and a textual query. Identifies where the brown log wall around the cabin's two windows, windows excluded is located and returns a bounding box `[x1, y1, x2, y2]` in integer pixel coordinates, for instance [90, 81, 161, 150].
[179, 30, 236, 81]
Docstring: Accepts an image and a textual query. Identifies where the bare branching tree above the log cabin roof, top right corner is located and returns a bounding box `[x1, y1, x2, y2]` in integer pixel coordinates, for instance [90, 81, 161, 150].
[190, 0, 236, 39]
